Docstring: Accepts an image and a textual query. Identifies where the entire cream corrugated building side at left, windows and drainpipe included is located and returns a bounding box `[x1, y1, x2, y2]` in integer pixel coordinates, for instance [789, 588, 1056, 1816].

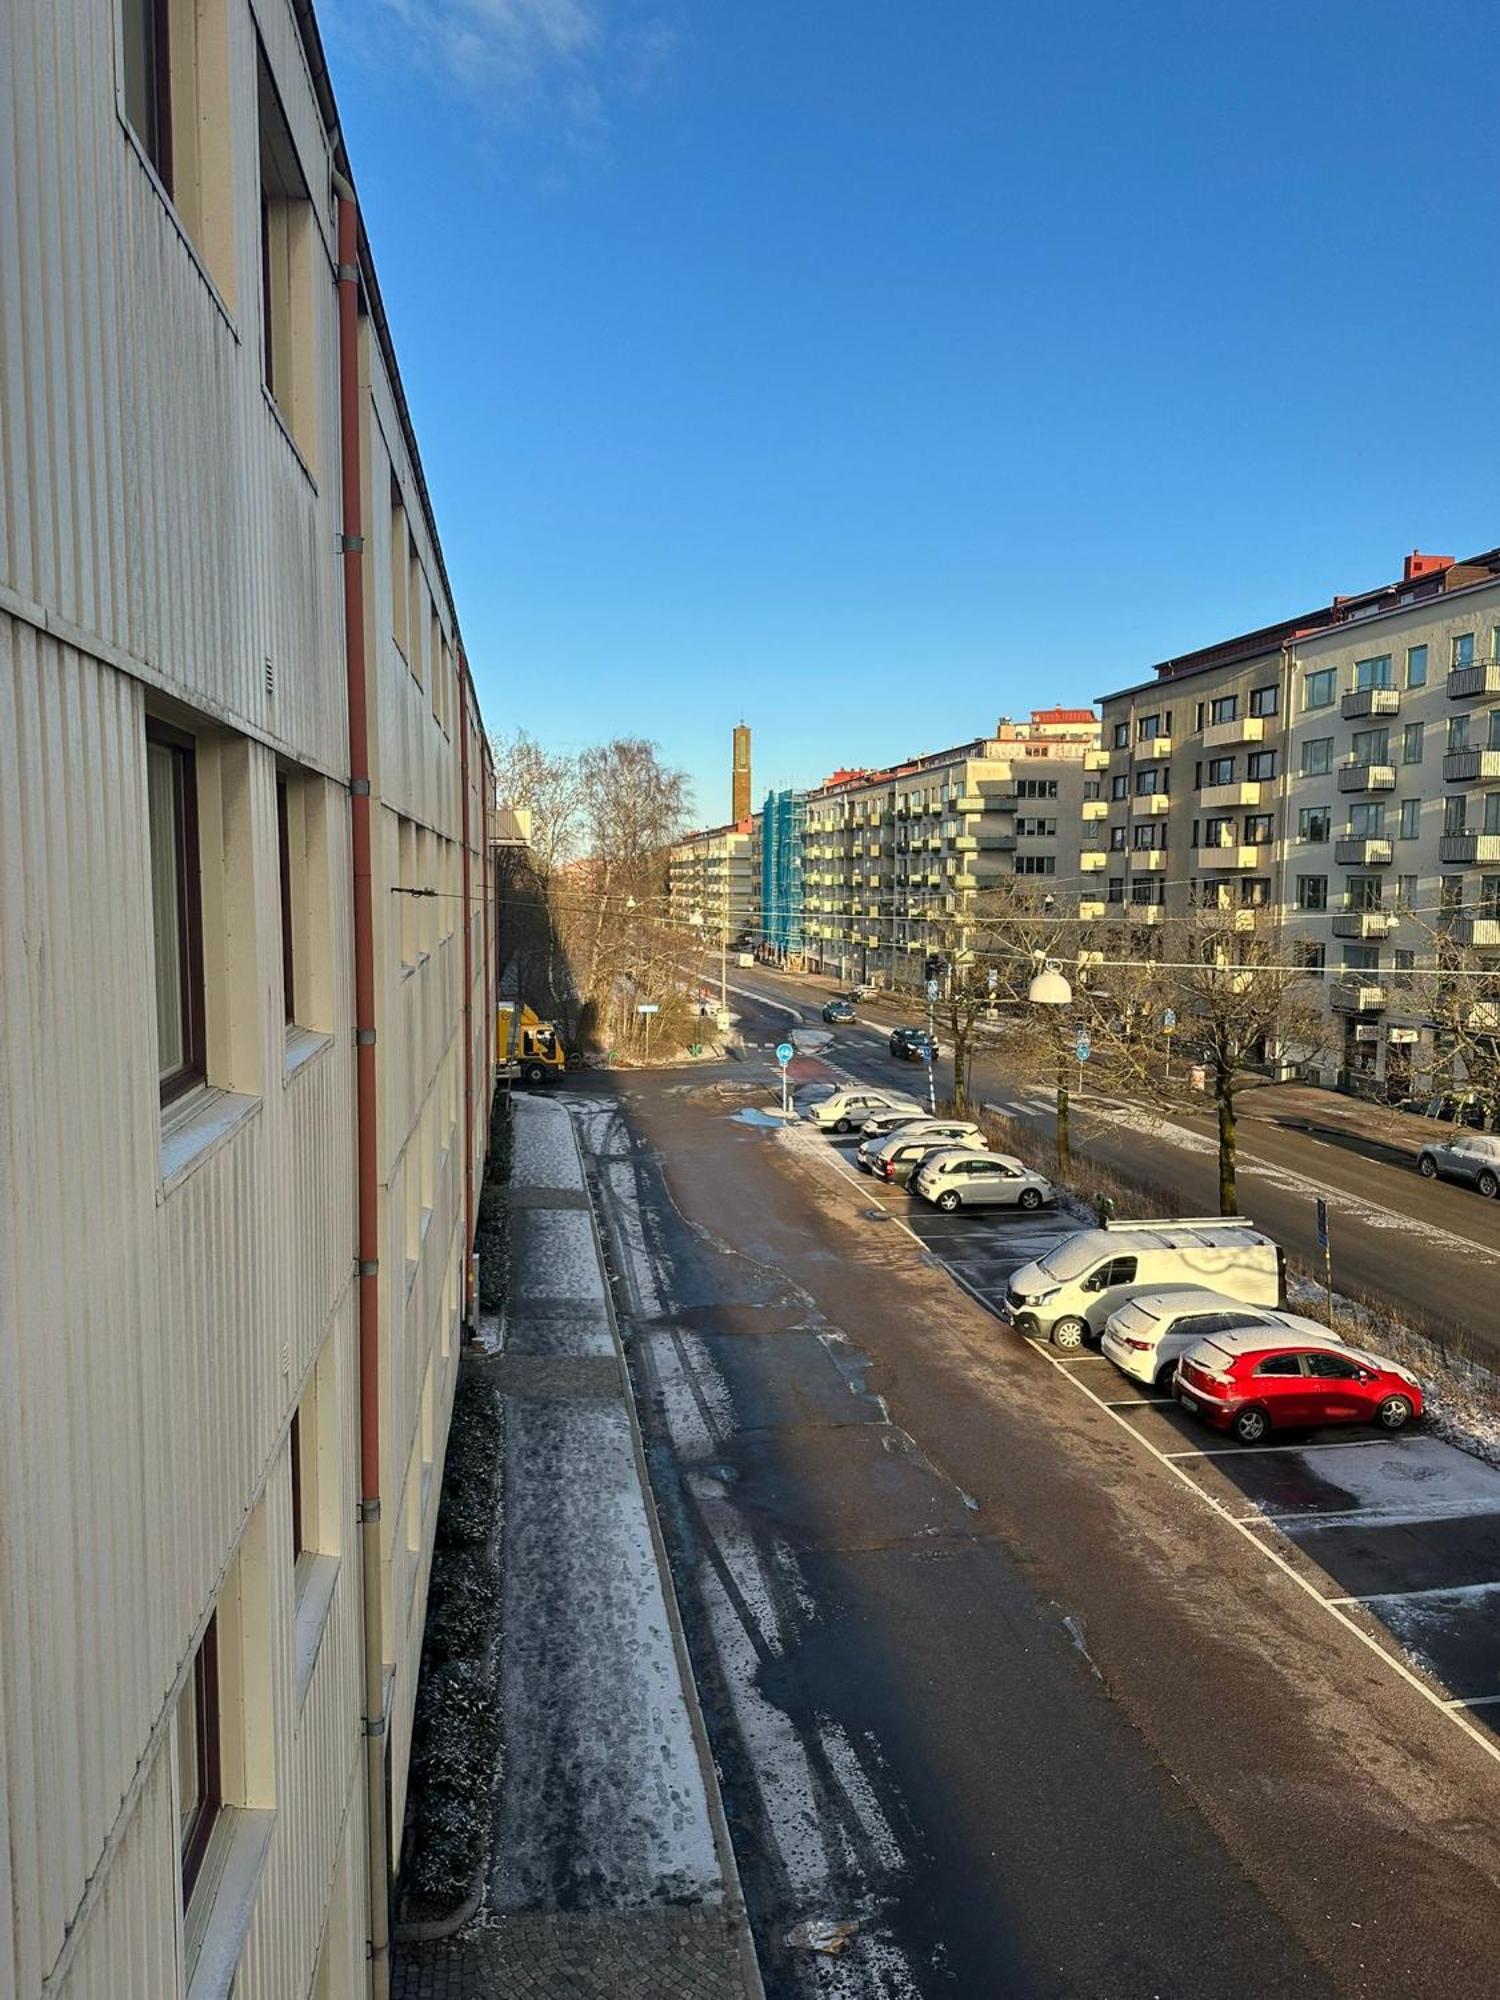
[0, 0, 494, 2000]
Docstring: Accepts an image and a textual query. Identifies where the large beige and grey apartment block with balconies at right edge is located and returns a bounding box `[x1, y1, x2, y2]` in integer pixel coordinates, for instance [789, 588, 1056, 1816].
[1096, 550, 1500, 1096]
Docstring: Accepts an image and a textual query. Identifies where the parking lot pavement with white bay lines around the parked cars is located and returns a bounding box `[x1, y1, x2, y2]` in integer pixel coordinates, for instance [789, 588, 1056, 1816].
[784, 1062, 1500, 1756]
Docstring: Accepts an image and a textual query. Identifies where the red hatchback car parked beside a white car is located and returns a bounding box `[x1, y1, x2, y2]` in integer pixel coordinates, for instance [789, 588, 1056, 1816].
[1176, 1326, 1422, 1444]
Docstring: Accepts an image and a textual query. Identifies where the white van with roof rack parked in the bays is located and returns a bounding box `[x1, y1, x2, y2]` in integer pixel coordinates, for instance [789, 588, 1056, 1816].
[1004, 1216, 1286, 1348]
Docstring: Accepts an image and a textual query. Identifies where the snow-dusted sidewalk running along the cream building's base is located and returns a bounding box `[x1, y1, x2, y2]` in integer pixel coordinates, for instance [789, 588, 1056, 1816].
[394, 1096, 760, 2000]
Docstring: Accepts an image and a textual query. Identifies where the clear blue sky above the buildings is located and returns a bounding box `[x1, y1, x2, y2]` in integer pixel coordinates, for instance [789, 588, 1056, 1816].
[322, 0, 1500, 820]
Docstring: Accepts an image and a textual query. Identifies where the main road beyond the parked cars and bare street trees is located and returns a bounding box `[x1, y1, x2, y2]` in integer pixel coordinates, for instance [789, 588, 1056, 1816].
[712, 966, 1500, 1364]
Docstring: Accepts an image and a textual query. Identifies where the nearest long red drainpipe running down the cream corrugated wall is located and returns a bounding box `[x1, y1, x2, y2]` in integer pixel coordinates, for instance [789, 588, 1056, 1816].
[336, 176, 390, 2000]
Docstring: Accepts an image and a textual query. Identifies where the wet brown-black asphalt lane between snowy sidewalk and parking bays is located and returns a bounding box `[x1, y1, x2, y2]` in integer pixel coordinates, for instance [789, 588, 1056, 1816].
[576, 1032, 1500, 2000]
